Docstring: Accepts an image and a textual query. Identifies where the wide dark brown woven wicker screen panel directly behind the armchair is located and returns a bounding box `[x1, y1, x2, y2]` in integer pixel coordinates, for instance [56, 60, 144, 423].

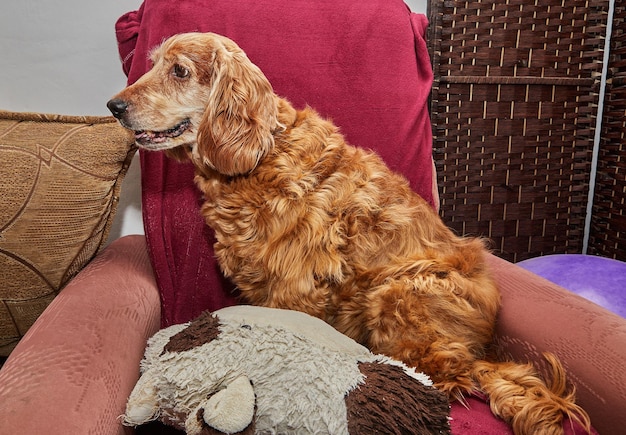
[429, 0, 608, 261]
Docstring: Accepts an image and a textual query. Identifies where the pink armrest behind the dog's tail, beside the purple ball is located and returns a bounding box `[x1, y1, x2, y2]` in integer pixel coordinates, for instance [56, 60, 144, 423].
[488, 256, 626, 434]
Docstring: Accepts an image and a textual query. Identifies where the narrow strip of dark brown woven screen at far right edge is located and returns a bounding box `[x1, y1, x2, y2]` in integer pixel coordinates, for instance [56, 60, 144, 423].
[589, 0, 626, 261]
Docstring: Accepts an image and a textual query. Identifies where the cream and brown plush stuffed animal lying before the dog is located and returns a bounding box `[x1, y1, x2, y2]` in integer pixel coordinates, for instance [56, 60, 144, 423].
[124, 305, 450, 435]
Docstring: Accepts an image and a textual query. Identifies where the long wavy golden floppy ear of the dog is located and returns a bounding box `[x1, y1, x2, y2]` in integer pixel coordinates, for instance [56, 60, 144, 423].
[195, 40, 278, 175]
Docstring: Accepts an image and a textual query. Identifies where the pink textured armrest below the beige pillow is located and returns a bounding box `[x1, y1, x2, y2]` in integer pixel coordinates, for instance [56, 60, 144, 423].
[0, 236, 161, 435]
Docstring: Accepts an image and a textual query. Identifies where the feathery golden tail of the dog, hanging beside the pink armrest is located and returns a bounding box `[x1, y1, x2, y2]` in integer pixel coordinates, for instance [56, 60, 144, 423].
[472, 353, 591, 435]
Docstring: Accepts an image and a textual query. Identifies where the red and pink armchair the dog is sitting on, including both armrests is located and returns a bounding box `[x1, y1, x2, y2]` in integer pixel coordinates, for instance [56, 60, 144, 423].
[0, 0, 626, 435]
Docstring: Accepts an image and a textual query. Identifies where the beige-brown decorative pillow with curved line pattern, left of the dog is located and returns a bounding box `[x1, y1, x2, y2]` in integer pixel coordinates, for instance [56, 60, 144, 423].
[0, 111, 135, 356]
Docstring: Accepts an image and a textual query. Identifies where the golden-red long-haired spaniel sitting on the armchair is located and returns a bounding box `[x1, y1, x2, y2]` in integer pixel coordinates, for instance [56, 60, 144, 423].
[107, 33, 590, 434]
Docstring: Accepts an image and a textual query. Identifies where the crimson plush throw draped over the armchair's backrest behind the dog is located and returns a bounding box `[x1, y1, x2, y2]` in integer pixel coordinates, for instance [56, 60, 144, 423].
[116, 0, 434, 325]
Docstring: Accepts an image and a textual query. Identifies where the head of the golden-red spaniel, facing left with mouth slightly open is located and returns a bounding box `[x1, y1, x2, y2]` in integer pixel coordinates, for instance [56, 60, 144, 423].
[107, 33, 279, 175]
